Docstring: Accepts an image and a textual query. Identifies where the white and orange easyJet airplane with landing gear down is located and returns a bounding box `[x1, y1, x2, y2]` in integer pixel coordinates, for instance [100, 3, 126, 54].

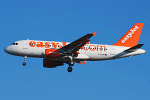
[4, 23, 146, 72]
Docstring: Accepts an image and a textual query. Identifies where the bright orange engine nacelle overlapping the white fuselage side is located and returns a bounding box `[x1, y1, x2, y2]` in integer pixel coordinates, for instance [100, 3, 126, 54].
[46, 49, 60, 58]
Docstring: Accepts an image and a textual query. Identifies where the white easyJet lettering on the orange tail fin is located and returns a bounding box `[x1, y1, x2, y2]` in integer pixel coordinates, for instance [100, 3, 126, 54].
[121, 25, 139, 43]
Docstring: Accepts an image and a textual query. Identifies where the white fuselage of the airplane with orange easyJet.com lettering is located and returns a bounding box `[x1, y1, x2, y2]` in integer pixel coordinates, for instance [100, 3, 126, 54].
[5, 40, 145, 62]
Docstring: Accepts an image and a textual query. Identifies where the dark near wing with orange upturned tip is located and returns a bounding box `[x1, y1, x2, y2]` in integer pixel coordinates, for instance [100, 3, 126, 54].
[59, 32, 97, 55]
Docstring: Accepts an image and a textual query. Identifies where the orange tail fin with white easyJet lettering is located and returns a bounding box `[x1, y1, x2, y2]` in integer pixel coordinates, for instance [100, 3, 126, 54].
[113, 23, 144, 47]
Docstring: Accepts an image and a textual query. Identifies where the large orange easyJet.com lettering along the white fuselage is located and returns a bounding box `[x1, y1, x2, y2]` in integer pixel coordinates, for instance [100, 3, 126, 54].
[29, 41, 107, 52]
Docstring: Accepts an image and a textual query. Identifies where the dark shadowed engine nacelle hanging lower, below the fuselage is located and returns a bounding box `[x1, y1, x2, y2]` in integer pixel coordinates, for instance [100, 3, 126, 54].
[43, 59, 63, 68]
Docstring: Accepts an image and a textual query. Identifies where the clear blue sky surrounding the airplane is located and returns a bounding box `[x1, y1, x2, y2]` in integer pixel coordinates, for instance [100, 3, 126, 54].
[0, 0, 150, 100]
